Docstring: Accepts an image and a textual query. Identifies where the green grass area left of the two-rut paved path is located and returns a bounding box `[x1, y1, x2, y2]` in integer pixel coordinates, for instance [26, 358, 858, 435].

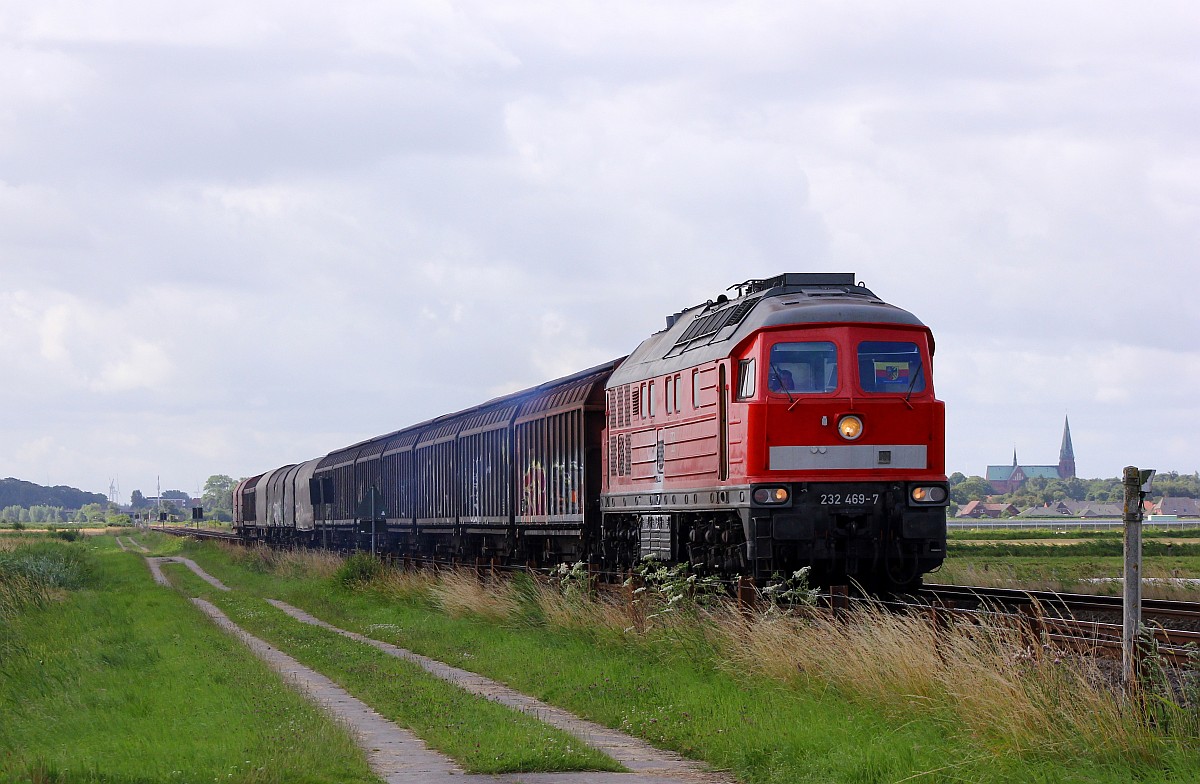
[0, 538, 377, 784]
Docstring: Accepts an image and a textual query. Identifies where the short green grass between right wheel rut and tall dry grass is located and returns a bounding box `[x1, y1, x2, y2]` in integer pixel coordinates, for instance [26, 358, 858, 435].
[169, 537, 1200, 784]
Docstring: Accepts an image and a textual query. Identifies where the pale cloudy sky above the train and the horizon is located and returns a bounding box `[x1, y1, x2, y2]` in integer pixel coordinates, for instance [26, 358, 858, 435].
[0, 0, 1200, 498]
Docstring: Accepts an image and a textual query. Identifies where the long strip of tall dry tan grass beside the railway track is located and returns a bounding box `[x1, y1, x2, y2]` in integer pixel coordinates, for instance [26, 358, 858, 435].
[428, 570, 1180, 760]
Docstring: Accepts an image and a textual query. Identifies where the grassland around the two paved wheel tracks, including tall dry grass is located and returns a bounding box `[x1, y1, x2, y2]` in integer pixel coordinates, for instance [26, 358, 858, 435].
[0, 534, 1200, 784]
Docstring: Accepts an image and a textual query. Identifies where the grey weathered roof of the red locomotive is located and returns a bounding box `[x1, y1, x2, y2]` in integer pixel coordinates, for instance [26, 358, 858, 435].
[607, 273, 924, 388]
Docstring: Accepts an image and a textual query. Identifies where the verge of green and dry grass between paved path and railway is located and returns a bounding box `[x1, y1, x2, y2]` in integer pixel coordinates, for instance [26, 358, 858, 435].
[162, 537, 1200, 784]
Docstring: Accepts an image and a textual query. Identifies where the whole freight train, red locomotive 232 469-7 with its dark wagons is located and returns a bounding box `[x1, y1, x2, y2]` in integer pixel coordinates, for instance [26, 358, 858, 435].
[234, 274, 948, 588]
